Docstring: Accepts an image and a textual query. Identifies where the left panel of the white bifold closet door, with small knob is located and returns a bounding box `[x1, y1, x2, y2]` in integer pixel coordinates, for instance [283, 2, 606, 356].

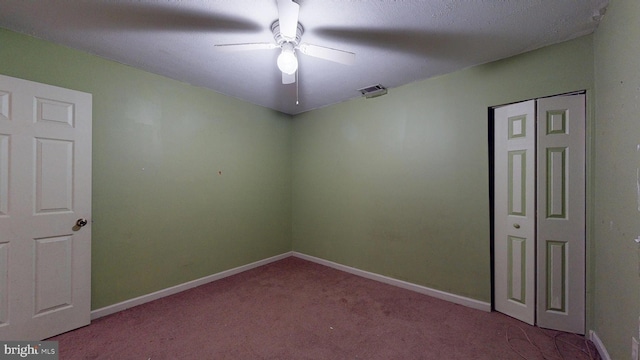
[494, 100, 536, 325]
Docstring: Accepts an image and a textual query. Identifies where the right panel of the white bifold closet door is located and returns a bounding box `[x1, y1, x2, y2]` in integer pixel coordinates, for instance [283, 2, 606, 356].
[537, 95, 586, 334]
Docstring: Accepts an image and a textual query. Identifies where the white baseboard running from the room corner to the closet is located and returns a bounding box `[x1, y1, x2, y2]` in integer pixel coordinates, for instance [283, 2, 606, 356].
[293, 251, 491, 312]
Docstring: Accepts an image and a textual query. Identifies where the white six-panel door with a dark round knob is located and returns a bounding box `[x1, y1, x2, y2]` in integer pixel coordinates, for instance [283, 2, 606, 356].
[0, 75, 92, 340]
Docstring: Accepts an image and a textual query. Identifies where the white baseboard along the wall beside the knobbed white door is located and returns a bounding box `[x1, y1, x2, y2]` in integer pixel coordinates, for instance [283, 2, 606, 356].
[91, 251, 293, 320]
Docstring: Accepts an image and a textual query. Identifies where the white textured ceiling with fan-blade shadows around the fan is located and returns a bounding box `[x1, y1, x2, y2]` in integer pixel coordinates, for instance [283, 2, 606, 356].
[0, 0, 608, 114]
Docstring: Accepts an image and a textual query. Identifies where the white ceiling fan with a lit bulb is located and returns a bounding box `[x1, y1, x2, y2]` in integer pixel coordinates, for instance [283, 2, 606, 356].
[214, 0, 356, 84]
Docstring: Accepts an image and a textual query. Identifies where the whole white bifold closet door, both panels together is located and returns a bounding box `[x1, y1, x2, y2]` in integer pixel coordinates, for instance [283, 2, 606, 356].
[494, 94, 586, 334]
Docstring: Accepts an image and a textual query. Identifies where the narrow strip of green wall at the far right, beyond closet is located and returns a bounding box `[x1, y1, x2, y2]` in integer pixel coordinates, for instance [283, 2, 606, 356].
[594, 0, 640, 359]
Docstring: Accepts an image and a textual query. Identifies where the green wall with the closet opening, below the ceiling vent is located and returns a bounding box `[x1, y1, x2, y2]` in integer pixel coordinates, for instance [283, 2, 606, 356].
[292, 36, 593, 302]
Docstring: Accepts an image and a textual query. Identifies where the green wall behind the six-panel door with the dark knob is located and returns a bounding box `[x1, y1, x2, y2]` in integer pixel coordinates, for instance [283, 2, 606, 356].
[0, 30, 291, 309]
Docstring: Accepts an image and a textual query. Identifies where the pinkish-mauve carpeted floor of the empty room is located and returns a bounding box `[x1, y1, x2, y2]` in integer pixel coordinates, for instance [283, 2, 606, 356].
[49, 257, 600, 360]
